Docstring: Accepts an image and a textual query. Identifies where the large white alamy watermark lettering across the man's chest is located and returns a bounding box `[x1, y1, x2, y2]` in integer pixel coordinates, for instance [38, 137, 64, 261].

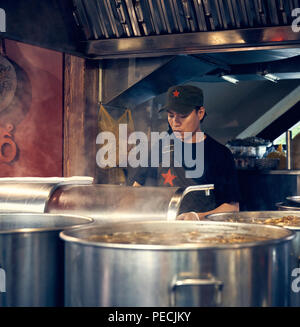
[96, 124, 204, 178]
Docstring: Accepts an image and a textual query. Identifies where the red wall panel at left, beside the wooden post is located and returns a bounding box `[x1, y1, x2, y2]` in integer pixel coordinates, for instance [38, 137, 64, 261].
[0, 40, 63, 177]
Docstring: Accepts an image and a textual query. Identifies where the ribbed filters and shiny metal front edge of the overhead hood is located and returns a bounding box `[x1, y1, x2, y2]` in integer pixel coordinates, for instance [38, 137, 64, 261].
[74, 0, 299, 59]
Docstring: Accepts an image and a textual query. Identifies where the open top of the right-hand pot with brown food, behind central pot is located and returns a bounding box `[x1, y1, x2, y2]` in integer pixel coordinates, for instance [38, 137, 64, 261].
[205, 211, 300, 231]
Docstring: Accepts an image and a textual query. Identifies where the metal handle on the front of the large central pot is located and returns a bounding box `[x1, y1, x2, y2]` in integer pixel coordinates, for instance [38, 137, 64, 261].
[170, 276, 224, 307]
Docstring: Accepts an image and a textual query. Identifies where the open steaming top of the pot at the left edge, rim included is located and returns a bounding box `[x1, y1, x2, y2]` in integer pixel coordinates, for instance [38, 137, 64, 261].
[0, 213, 94, 237]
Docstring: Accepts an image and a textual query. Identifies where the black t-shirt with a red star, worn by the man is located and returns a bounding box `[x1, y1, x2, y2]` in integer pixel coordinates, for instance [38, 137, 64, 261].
[130, 135, 239, 212]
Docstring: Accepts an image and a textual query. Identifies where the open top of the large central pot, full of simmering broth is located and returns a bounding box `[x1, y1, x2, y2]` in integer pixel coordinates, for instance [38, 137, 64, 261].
[60, 221, 295, 250]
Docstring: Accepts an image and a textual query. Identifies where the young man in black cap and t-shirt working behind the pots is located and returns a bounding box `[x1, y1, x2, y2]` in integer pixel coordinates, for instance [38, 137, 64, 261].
[131, 85, 239, 220]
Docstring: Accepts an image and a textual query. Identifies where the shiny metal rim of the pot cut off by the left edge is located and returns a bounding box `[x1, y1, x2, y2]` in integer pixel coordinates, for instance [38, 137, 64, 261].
[0, 212, 95, 236]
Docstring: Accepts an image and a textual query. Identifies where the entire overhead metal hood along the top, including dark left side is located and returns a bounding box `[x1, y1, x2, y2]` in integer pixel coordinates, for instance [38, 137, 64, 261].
[0, 0, 300, 59]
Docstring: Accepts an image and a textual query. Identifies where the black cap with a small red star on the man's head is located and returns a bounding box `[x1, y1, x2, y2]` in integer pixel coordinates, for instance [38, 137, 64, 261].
[159, 85, 203, 114]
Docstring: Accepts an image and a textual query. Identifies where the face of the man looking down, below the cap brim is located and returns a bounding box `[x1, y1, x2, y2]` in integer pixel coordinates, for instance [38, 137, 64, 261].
[168, 107, 205, 141]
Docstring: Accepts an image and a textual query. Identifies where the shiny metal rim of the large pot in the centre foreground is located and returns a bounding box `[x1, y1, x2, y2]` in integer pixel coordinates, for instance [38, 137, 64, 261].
[59, 220, 296, 251]
